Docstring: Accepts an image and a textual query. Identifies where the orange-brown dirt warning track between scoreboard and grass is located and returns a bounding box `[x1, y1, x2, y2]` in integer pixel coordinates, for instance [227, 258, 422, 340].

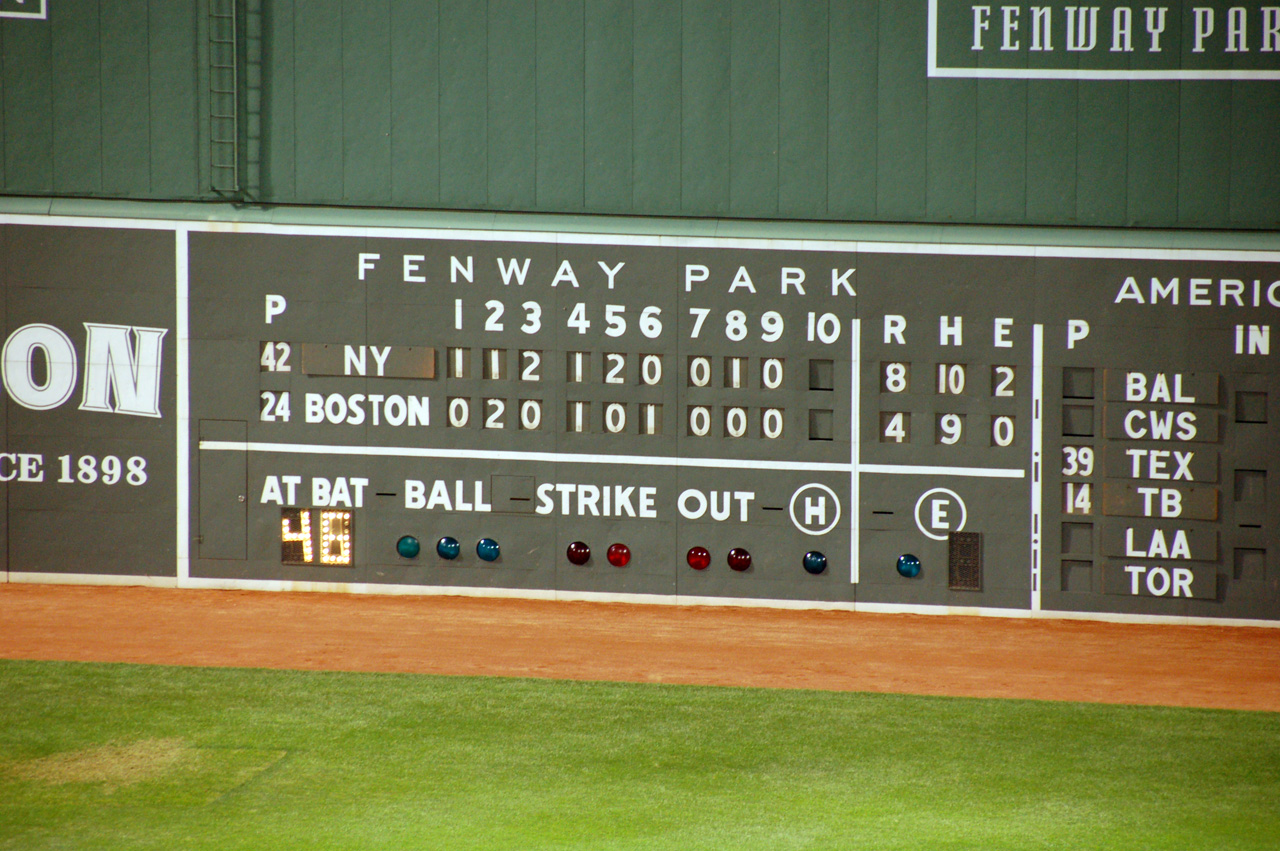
[0, 585, 1280, 712]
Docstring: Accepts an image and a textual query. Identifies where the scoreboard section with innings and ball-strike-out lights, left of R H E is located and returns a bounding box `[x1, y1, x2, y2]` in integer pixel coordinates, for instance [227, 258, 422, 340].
[191, 233, 856, 601]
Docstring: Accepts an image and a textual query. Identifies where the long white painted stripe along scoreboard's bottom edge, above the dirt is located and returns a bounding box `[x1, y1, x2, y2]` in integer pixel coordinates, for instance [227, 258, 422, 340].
[10, 572, 1280, 628]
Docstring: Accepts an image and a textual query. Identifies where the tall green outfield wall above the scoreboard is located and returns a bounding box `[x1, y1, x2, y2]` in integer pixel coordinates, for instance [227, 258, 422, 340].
[0, 0, 1280, 229]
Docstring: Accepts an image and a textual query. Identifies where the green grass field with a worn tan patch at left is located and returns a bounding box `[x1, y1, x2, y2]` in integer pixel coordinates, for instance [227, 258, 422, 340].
[0, 662, 1280, 851]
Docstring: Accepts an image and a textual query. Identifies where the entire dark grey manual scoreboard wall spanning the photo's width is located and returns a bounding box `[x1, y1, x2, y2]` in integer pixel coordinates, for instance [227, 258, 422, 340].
[0, 212, 1280, 622]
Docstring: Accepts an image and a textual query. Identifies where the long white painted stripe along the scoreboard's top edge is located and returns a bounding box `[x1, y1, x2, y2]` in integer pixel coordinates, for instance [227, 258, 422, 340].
[0, 214, 1280, 262]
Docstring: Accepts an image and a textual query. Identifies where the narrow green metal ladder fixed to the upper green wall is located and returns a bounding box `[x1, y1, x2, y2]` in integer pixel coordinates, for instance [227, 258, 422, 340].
[209, 0, 241, 193]
